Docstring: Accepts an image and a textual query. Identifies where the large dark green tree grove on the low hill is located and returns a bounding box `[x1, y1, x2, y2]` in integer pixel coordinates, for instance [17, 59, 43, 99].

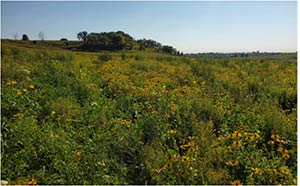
[77, 31, 183, 55]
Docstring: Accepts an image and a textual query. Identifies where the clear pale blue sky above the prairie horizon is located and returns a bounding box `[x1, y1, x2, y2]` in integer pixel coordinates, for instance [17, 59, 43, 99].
[1, 1, 297, 53]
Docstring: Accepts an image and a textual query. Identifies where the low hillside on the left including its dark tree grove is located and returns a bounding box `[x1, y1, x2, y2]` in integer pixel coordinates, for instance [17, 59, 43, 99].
[2, 31, 183, 55]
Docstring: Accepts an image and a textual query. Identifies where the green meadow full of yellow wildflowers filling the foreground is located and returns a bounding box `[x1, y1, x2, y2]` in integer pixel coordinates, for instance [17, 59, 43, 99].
[1, 41, 297, 185]
